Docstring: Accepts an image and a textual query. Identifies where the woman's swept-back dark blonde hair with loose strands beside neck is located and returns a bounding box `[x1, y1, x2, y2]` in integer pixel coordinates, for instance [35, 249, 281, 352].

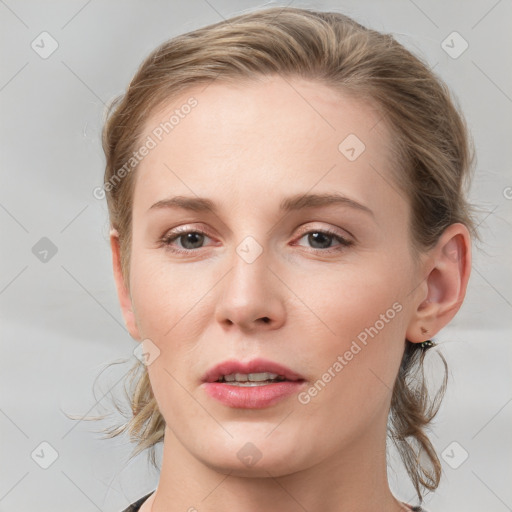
[90, 7, 478, 501]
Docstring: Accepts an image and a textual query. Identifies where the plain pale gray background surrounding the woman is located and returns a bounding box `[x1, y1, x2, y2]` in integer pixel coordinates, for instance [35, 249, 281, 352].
[0, 0, 512, 512]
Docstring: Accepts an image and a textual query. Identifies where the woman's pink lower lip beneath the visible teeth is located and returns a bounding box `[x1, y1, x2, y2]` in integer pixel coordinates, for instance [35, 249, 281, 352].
[204, 381, 305, 409]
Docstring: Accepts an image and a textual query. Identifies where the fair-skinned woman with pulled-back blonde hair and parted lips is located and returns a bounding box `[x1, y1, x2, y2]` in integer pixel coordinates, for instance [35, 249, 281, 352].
[98, 8, 476, 512]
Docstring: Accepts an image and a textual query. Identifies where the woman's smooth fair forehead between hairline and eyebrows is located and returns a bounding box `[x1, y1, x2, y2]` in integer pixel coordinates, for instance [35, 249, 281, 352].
[134, 76, 404, 218]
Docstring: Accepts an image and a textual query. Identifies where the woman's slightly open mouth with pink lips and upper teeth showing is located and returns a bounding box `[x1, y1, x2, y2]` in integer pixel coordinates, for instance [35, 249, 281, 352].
[203, 359, 306, 409]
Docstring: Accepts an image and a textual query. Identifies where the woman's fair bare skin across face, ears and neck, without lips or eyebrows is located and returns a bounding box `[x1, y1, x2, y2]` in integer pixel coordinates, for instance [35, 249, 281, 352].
[111, 77, 471, 512]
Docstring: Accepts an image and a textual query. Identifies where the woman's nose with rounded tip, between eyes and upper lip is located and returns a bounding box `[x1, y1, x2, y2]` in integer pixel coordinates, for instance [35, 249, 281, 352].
[216, 247, 286, 332]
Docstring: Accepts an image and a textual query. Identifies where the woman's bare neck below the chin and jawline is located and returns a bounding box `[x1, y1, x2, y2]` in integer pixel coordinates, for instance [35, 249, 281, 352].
[148, 427, 409, 512]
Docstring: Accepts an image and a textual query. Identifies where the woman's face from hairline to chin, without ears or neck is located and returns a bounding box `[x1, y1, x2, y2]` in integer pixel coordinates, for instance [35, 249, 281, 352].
[122, 77, 424, 476]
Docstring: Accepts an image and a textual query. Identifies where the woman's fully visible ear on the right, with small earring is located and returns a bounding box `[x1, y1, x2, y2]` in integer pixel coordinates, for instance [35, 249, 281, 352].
[406, 223, 471, 343]
